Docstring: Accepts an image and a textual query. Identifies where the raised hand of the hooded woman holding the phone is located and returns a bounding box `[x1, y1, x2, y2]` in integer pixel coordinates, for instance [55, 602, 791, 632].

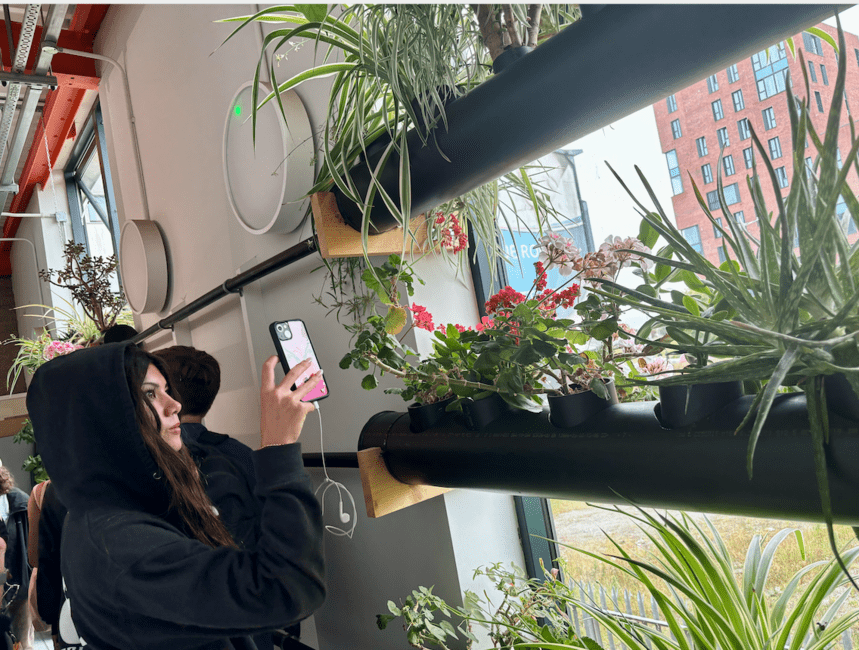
[260, 356, 322, 447]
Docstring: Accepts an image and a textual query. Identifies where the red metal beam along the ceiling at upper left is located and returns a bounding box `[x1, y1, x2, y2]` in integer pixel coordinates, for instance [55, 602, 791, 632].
[0, 5, 110, 275]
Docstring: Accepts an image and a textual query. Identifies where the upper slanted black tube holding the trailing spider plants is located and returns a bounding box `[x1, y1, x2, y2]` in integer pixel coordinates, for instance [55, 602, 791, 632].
[333, 3, 851, 231]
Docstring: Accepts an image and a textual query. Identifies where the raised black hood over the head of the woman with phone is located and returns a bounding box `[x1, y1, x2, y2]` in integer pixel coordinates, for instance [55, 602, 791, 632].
[27, 341, 169, 515]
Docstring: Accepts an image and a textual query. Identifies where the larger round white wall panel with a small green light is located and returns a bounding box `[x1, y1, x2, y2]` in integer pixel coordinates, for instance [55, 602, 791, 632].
[223, 81, 314, 235]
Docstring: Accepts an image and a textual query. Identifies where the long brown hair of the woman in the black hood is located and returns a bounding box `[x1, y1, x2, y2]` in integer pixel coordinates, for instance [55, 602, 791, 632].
[125, 345, 237, 548]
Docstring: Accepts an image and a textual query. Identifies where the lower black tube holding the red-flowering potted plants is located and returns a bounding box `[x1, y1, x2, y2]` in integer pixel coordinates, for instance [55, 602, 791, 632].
[358, 395, 859, 526]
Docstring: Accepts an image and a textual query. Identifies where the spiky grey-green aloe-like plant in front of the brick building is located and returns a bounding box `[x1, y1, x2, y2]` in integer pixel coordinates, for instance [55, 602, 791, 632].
[603, 16, 859, 588]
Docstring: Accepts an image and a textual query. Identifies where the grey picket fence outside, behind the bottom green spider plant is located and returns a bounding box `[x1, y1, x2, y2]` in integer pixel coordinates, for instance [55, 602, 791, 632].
[571, 582, 859, 650]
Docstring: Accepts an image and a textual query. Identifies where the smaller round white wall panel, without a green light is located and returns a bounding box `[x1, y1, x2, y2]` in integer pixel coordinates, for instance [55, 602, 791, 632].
[119, 220, 168, 314]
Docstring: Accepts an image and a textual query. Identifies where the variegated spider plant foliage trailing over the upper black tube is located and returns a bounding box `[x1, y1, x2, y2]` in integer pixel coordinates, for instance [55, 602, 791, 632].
[218, 4, 578, 270]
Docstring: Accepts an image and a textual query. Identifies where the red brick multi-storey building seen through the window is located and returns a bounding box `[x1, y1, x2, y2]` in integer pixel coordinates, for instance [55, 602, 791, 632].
[653, 24, 859, 263]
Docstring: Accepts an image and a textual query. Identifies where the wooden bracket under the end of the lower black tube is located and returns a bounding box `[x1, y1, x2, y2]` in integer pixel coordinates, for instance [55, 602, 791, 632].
[358, 447, 450, 519]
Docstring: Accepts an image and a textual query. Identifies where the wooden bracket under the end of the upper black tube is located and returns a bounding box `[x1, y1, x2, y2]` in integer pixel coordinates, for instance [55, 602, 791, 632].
[310, 192, 427, 259]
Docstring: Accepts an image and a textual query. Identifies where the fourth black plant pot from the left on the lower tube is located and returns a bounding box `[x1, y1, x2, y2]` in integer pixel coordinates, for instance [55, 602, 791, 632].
[657, 381, 743, 429]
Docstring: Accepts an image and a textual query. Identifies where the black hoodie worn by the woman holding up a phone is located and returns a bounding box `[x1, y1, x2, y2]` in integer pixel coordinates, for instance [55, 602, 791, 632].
[27, 342, 325, 650]
